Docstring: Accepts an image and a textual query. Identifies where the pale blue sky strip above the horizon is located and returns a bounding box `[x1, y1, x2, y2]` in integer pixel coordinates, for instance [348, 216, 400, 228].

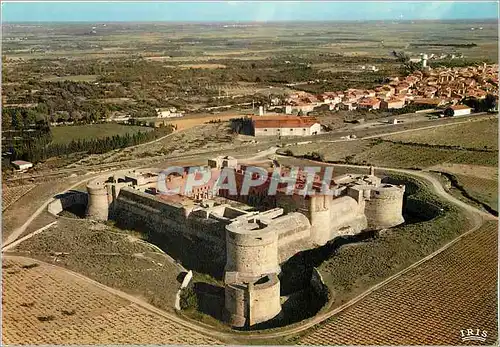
[2, 1, 498, 22]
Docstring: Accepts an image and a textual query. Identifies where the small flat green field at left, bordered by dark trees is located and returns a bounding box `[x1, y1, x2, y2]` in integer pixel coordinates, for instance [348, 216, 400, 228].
[52, 123, 153, 144]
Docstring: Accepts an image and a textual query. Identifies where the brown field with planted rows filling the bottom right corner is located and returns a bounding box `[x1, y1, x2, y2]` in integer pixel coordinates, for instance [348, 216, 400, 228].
[299, 222, 498, 345]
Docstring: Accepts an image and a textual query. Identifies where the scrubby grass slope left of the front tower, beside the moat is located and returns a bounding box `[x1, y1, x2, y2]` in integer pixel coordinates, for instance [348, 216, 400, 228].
[9, 218, 182, 311]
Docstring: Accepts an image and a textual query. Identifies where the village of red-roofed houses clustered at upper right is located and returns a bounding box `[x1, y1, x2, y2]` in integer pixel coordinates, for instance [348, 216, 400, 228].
[285, 61, 498, 114]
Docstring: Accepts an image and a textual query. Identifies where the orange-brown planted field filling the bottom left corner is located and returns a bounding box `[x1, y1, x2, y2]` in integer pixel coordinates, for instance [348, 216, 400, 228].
[2, 256, 220, 345]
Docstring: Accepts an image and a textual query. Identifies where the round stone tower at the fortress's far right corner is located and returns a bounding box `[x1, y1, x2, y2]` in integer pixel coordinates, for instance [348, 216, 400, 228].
[365, 184, 405, 229]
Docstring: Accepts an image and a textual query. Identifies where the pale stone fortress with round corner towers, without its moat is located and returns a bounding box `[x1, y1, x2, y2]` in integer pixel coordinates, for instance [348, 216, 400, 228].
[87, 157, 405, 327]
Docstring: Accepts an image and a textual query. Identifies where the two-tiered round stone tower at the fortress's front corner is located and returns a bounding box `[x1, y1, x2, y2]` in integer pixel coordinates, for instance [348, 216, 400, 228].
[224, 217, 281, 327]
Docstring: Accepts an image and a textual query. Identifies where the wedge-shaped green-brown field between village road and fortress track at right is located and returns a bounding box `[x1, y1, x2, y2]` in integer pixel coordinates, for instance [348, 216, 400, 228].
[282, 118, 498, 169]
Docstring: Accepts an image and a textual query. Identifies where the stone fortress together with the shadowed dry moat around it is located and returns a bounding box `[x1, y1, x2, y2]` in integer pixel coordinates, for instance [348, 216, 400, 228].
[49, 157, 446, 330]
